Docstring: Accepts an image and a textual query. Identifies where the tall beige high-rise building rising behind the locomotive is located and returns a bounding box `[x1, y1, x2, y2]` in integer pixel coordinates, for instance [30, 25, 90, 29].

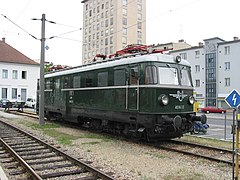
[82, 0, 146, 64]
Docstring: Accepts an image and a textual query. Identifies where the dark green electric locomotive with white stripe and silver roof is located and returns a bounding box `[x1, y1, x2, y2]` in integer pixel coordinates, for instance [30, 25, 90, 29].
[41, 53, 206, 140]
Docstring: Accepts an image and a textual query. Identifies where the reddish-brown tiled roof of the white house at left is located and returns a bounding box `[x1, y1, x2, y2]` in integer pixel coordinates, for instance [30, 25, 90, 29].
[0, 41, 39, 65]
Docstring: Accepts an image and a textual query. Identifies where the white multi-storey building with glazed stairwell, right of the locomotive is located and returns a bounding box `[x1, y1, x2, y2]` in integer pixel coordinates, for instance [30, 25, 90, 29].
[170, 37, 240, 108]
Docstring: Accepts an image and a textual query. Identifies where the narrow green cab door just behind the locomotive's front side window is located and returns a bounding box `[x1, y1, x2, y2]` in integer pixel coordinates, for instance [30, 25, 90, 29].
[127, 65, 139, 111]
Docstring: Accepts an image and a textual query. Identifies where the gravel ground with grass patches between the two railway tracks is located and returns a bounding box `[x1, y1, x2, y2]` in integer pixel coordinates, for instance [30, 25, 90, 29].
[0, 114, 232, 180]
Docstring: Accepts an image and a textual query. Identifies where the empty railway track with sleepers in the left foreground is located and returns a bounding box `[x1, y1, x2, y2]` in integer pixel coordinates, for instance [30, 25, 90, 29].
[0, 120, 113, 180]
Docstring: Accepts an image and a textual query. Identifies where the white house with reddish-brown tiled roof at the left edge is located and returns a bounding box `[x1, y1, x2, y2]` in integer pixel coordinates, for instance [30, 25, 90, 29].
[0, 38, 40, 101]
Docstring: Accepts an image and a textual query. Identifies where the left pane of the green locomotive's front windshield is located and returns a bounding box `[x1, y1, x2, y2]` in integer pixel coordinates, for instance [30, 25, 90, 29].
[159, 67, 179, 85]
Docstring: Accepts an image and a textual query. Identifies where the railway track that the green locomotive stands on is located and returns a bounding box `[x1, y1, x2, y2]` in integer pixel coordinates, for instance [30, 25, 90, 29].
[5, 111, 236, 165]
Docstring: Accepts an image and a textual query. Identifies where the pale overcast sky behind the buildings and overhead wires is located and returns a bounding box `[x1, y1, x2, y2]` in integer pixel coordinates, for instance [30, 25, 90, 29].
[0, 0, 240, 66]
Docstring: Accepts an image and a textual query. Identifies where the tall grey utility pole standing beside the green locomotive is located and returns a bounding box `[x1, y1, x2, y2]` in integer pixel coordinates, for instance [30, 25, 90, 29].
[39, 14, 46, 125]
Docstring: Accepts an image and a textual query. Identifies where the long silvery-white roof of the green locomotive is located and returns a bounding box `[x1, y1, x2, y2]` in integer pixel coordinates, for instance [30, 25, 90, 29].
[45, 53, 190, 78]
